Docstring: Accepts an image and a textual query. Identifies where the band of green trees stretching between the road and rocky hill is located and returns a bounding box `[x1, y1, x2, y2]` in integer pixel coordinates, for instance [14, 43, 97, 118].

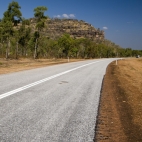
[0, 1, 142, 59]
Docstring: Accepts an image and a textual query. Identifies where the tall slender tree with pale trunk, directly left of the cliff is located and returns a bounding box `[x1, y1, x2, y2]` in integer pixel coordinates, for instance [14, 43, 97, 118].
[34, 6, 47, 59]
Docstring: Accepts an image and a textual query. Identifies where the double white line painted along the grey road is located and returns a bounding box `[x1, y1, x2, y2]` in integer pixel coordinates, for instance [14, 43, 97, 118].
[0, 60, 104, 99]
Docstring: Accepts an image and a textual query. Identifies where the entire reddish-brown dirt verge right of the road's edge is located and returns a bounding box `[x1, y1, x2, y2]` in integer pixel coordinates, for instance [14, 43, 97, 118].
[94, 59, 142, 142]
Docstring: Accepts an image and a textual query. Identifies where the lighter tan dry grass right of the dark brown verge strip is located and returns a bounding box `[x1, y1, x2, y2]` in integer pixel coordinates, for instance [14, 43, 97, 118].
[117, 59, 142, 129]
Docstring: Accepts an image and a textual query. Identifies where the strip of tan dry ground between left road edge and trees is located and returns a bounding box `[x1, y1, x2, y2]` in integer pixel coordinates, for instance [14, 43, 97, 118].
[0, 59, 83, 74]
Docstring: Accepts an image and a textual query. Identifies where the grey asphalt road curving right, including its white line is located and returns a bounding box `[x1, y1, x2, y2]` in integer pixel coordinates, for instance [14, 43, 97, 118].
[0, 59, 115, 142]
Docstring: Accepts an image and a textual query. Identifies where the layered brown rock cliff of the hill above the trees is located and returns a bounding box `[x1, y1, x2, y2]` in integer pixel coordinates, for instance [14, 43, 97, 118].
[30, 19, 104, 41]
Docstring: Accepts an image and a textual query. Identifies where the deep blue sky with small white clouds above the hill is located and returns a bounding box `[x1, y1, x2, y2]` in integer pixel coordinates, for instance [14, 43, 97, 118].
[0, 0, 142, 50]
